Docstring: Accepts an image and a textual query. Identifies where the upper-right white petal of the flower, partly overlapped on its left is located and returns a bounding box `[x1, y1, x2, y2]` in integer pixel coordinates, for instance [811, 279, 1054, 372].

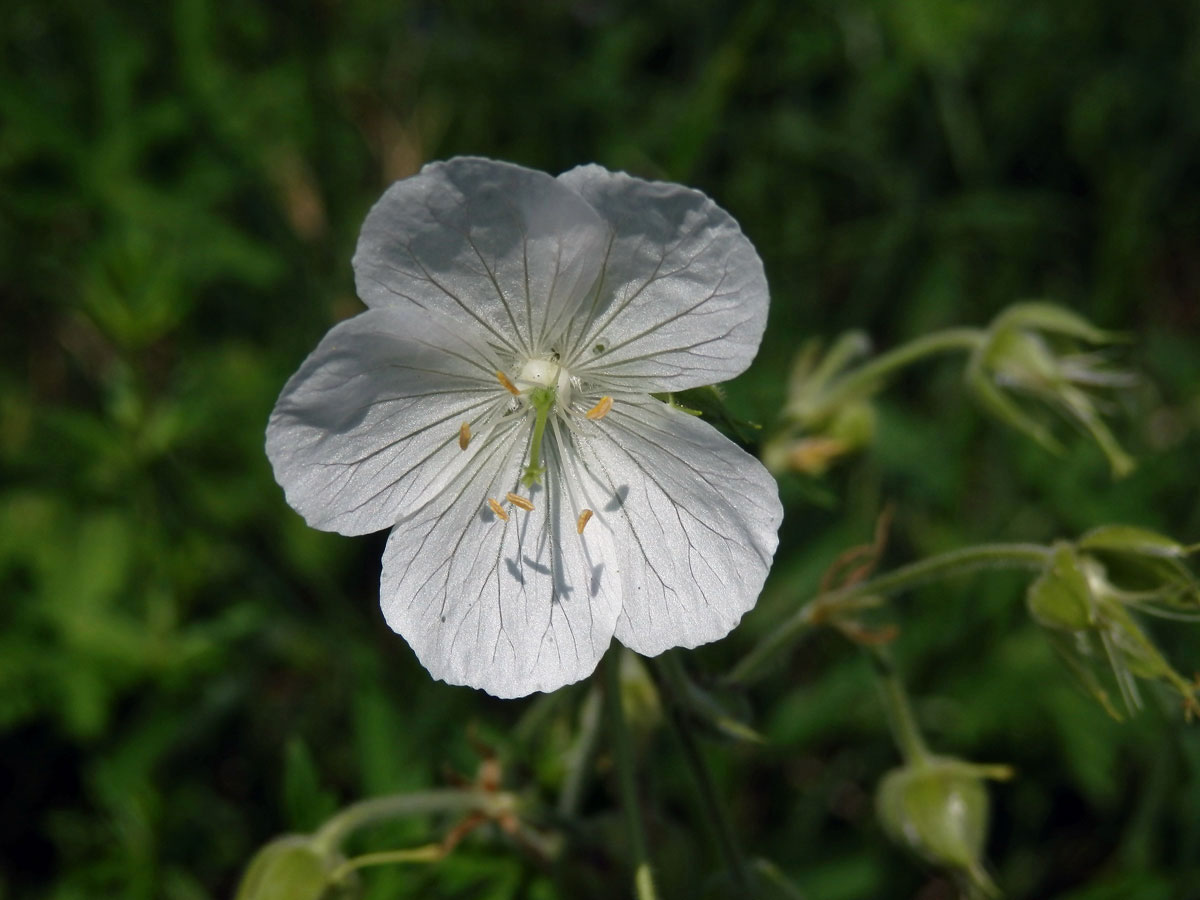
[558, 166, 768, 392]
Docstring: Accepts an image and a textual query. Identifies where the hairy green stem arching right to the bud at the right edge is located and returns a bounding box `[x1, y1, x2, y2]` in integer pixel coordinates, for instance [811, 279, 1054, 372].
[725, 544, 1051, 683]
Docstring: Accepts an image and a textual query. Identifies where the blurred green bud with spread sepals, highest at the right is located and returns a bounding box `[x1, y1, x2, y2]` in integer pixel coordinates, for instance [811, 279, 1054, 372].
[967, 304, 1134, 478]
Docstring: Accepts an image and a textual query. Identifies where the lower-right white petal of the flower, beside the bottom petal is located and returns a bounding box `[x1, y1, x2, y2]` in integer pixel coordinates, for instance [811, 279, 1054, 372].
[581, 398, 784, 655]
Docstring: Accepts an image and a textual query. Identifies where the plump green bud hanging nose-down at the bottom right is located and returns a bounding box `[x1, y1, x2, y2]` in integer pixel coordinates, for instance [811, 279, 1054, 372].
[875, 756, 1012, 894]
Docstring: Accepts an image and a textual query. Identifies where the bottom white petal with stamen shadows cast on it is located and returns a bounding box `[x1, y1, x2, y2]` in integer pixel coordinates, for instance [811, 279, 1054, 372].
[379, 430, 622, 697]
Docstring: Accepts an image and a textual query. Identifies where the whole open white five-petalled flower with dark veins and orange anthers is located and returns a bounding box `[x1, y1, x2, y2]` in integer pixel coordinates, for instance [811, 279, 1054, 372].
[266, 158, 782, 697]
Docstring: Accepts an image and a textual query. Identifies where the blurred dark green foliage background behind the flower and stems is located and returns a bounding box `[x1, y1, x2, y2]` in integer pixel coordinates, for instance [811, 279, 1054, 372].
[0, 0, 1200, 900]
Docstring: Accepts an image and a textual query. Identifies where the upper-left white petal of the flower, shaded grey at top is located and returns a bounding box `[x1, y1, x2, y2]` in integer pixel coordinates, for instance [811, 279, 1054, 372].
[354, 157, 608, 355]
